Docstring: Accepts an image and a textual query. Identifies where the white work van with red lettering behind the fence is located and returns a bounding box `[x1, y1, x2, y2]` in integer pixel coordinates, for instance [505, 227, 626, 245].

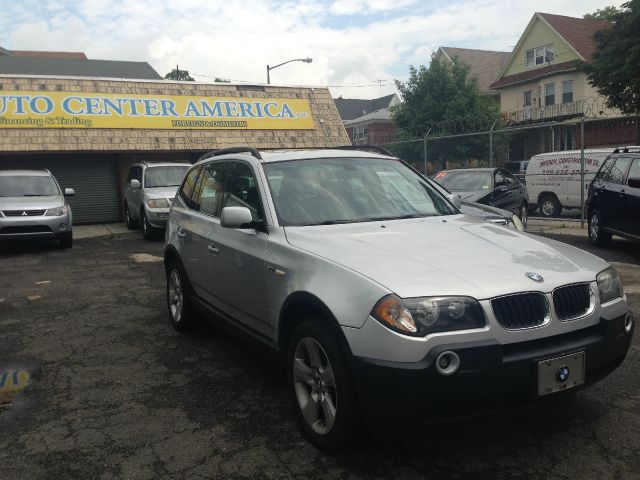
[525, 148, 613, 217]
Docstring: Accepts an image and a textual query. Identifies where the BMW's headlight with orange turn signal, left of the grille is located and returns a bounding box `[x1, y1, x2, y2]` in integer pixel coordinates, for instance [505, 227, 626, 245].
[371, 295, 486, 337]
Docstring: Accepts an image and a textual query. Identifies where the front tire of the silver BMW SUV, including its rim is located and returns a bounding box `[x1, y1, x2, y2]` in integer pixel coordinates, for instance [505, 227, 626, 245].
[287, 318, 360, 450]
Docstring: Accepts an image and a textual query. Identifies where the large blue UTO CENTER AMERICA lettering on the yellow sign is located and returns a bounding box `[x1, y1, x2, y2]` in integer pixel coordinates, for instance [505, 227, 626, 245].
[0, 95, 299, 118]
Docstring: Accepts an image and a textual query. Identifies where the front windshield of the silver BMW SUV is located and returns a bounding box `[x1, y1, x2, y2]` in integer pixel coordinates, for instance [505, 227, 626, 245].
[264, 158, 458, 226]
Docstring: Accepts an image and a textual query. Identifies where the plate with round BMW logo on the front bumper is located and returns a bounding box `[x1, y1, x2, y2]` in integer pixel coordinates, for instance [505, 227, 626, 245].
[538, 352, 584, 396]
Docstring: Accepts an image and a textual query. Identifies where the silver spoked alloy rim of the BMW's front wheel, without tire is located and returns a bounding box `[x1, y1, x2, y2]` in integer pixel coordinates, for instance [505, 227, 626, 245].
[293, 337, 338, 435]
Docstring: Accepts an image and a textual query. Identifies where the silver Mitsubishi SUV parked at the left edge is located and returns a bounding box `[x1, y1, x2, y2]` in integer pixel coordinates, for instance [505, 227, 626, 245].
[0, 170, 75, 248]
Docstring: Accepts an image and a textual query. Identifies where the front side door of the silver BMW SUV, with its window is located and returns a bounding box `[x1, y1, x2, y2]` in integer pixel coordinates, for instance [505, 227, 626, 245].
[207, 160, 272, 338]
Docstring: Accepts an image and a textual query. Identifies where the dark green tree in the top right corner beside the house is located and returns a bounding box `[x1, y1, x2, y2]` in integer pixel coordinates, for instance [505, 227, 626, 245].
[581, 0, 640, 114]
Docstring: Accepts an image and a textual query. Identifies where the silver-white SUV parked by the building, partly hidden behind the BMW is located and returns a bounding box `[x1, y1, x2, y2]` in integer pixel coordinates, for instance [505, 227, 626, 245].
[122, 162, 191, 240]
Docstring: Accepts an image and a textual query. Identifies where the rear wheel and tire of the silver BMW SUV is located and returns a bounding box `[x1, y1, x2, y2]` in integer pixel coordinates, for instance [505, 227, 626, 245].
[166, 260, 197, 333]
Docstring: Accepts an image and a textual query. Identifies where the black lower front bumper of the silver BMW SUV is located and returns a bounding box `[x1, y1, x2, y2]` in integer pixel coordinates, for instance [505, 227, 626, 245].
[352, 313, 634, 429]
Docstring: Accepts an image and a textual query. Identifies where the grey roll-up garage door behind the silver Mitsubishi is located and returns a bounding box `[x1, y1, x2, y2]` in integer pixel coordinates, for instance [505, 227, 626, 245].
[0, 153, 121, 224]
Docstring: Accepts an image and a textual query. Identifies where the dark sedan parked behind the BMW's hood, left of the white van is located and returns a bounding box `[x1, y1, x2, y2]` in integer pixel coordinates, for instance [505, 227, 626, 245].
[433, 167, 529, 226]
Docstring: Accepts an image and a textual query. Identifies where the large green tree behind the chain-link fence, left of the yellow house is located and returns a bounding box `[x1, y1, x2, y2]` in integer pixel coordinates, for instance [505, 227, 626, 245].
[393, 56, 500, 169]
